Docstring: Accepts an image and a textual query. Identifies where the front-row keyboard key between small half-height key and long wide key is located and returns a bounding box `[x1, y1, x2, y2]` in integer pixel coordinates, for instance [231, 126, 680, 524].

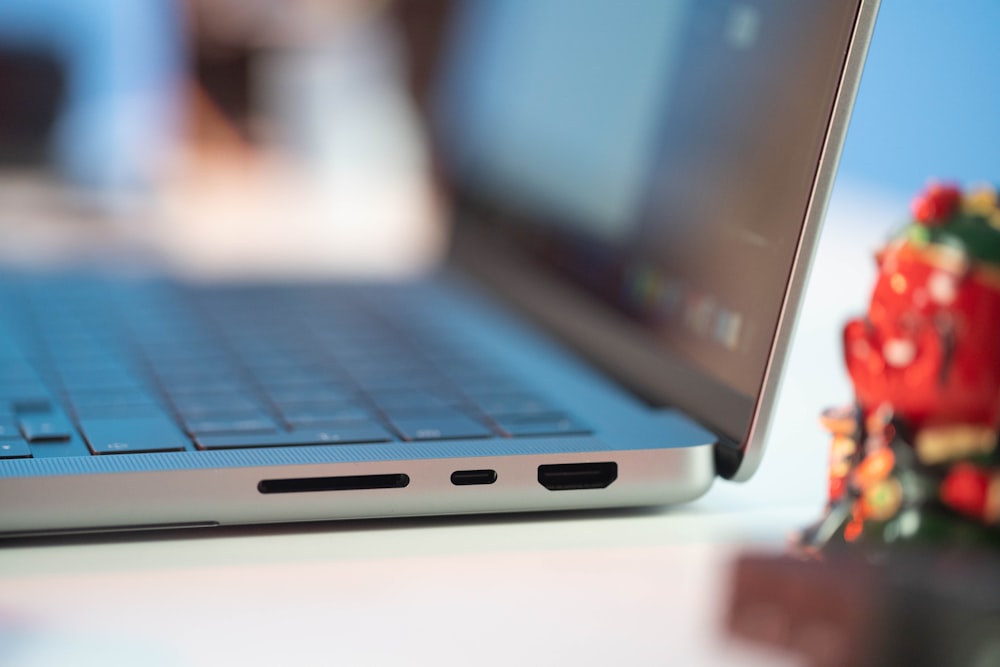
[80, 415, 190, 454]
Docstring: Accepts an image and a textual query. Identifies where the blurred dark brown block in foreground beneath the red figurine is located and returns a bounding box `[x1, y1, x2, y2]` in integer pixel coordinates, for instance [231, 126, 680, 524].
[726, 550, 1000, 667]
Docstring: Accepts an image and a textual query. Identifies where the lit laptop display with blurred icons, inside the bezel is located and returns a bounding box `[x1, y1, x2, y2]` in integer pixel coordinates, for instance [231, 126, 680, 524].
[438, 0, 857, 434]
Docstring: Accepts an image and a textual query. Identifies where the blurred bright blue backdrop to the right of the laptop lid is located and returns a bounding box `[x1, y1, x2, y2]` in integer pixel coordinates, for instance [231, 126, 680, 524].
[839, 0, 1000, 196]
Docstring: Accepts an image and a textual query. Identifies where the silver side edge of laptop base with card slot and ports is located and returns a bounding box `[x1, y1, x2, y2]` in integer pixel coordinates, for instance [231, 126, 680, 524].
[0, 444, 715, 537]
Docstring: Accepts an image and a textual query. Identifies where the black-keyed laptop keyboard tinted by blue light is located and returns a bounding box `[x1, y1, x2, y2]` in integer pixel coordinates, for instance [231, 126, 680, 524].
[0, 277, 588, 458]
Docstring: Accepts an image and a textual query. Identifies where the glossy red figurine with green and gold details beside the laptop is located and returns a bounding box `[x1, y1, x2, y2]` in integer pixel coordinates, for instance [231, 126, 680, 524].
[799, 184, 1000, 551]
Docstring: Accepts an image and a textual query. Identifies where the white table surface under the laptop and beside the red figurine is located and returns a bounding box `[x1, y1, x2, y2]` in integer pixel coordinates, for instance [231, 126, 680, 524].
[0, 180, 906, 665]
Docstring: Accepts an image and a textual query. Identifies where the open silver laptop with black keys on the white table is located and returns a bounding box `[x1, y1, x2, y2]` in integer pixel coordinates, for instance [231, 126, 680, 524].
[0, 0, 876, 536]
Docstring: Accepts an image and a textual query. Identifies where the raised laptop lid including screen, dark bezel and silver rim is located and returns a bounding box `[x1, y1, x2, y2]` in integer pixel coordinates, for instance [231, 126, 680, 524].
[435, 0, 876, 479]
